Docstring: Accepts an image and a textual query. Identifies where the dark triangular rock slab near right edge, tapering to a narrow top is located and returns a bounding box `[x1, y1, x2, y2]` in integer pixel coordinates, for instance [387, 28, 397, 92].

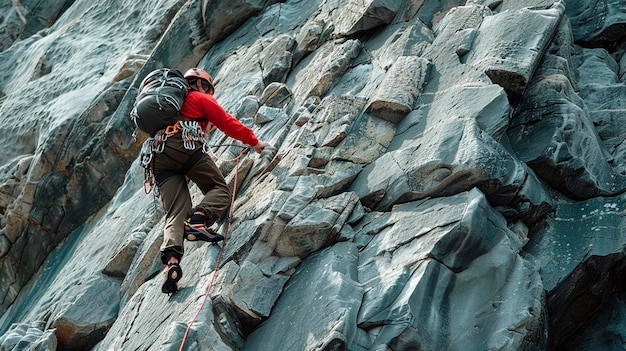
[507, 19, 626, 200]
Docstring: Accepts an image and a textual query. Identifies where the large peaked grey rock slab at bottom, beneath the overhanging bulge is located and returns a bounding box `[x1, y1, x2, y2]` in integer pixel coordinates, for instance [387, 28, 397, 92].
[357, 190, 547, 350]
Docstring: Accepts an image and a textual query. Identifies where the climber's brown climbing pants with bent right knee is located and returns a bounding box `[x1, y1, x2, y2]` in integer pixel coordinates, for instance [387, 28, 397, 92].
[152, 133, 231, 264]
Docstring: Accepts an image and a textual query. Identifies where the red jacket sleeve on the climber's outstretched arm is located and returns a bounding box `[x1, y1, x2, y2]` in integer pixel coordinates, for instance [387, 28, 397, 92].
[203, 94, 259, 146]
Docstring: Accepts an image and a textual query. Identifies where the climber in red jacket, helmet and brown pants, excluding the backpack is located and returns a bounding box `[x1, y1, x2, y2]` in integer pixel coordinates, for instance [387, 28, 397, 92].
[151, 68, 269, 294]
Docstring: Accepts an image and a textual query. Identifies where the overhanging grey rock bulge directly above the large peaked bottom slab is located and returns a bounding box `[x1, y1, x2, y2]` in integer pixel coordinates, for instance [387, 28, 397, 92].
[351, 97, 551, 223]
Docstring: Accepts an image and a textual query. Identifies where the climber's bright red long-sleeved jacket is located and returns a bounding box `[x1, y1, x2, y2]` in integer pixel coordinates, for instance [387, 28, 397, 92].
[180, 90, 259, 146]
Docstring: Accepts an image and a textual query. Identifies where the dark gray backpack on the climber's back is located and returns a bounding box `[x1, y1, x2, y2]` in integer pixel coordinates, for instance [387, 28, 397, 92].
[130, 68, 189, 137]
